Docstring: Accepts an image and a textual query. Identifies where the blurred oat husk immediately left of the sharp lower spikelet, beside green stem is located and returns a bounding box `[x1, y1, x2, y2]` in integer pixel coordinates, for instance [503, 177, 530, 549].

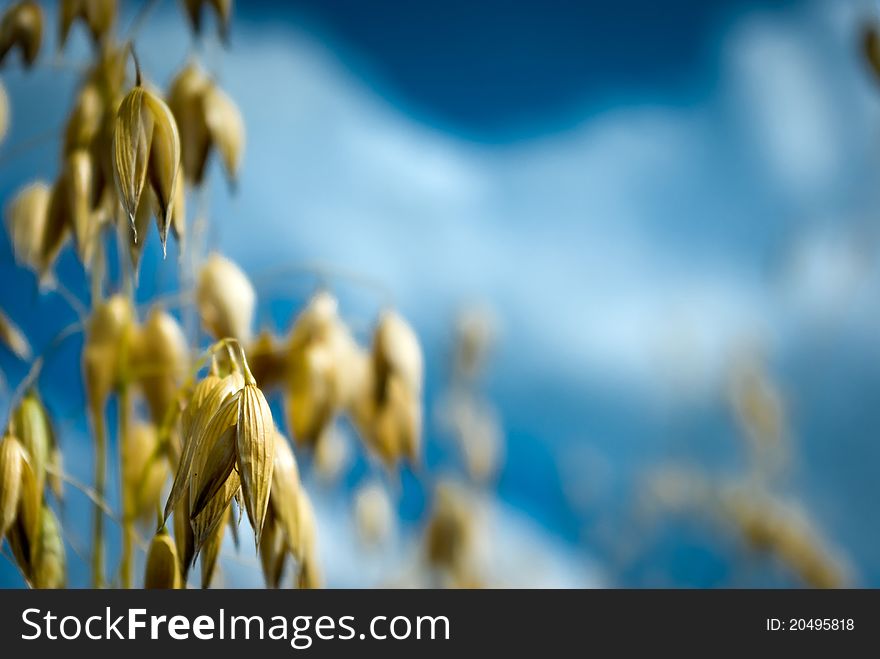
[122, 422, 168, 520]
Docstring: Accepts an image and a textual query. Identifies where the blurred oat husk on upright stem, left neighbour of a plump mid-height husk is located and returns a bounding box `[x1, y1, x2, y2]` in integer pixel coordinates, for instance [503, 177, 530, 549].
[83, 295, 134, 413]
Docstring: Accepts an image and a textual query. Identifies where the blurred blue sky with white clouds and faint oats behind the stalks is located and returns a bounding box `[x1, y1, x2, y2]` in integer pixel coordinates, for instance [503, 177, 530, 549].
[0, 0, 880, 587]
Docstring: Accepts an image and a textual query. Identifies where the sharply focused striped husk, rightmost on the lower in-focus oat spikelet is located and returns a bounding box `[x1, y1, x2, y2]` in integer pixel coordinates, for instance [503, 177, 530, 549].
[235, 383, 275, 546]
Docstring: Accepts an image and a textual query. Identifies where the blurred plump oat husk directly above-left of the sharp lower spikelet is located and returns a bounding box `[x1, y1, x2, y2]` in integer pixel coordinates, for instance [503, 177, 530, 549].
[131, 307, 189, 424]
